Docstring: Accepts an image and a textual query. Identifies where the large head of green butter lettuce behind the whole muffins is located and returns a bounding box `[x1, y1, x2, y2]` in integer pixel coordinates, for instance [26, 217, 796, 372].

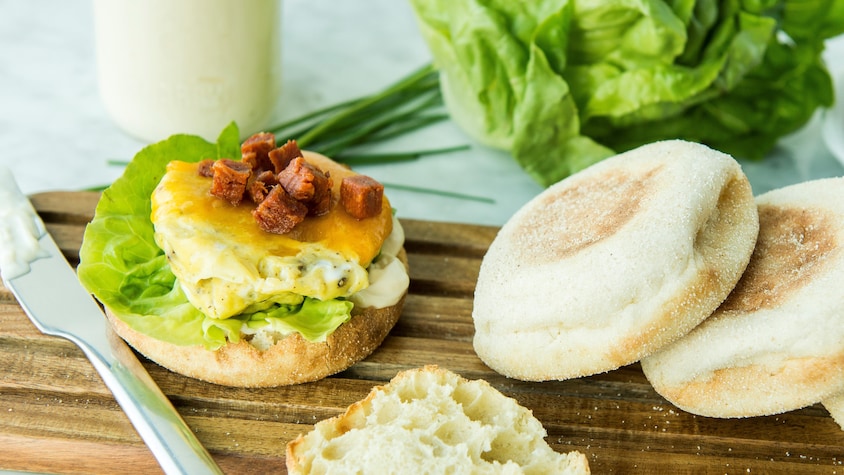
[411, 0, 844, 185]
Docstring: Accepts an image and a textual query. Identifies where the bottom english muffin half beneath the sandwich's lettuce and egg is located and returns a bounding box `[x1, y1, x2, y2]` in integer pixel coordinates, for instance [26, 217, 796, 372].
[106, 250, 407, 388]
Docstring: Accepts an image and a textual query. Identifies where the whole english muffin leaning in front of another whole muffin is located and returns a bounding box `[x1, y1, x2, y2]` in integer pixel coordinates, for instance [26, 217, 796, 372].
[473, 140, 758, 381]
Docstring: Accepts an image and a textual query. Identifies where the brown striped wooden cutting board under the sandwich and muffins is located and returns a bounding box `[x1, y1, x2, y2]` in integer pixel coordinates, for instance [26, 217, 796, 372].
[0, 192, 844, 474]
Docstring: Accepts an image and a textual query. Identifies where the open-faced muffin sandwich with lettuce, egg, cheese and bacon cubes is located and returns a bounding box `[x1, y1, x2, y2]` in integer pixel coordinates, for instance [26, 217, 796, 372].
[78, 125, 409, 387]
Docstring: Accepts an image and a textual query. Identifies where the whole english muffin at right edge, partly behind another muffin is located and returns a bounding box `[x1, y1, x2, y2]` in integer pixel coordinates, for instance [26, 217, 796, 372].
[642, 178, 844, 421]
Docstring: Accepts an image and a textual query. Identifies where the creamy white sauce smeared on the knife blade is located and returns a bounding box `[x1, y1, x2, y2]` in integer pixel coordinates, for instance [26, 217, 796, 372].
[0, 167, 46, 280]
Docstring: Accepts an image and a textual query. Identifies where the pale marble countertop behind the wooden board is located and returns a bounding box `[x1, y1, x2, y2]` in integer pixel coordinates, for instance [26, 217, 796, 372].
[0, 0, 844, 225]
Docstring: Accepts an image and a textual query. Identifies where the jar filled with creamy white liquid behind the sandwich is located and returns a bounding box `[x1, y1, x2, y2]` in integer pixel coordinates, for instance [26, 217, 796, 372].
[94, 0, 281, 142]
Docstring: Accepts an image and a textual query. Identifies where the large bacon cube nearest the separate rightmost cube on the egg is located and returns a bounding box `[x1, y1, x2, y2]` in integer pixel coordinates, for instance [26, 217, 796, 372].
[278, 157, 333, 216]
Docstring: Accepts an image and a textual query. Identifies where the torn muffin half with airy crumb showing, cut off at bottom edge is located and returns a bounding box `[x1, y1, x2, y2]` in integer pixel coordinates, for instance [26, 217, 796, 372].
[286, 366, 590, 475]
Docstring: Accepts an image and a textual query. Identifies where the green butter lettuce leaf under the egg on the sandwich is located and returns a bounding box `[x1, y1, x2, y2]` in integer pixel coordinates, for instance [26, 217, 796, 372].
[77, 124, 352, 350]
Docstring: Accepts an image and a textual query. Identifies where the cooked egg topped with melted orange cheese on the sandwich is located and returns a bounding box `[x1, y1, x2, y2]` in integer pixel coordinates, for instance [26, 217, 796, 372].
[151, 159, 394, 318]
